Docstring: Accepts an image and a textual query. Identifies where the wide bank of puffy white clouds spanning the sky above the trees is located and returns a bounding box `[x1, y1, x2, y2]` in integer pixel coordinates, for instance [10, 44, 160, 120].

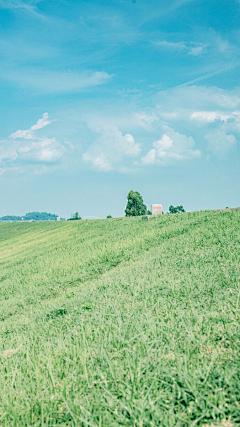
[0, 86, 240, 174]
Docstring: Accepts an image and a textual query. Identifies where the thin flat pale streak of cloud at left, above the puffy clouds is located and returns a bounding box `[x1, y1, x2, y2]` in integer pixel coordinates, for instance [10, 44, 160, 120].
[0, 69, 111, 93]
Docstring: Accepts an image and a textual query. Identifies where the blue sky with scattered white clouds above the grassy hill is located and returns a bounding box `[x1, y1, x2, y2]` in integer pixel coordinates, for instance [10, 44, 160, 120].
[0, 0, 240, 218]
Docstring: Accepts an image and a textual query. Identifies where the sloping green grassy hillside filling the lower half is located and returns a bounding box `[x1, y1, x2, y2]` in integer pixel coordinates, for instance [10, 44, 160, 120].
[0, 211, 240, 427]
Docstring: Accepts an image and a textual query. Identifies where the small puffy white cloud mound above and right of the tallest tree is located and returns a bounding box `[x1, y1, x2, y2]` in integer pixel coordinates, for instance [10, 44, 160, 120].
[141, 126, 201, 166]
